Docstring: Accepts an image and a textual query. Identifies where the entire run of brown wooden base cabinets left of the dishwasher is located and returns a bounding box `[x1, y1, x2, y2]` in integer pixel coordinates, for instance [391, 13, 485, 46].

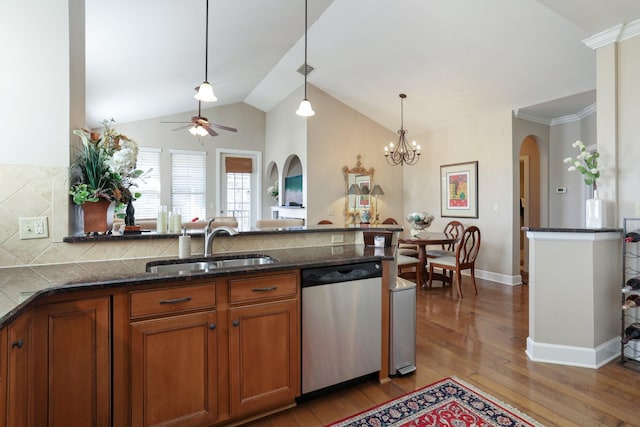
[0, 271, 300, 427]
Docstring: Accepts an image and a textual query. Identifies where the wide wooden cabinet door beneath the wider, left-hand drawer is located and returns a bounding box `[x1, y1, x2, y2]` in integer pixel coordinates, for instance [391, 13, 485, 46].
[131, 312, 218, 427]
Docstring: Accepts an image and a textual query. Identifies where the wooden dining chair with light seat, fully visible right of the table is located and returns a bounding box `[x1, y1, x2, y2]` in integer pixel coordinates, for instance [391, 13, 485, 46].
[429, 225, 480, 298]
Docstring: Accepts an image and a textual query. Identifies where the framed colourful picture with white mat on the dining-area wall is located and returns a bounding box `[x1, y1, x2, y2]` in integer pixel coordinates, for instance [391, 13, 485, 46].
[440, 161, 478, 218]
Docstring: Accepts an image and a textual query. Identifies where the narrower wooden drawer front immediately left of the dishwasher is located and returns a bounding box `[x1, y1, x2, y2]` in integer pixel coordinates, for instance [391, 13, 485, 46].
[229, 273, 298, 303]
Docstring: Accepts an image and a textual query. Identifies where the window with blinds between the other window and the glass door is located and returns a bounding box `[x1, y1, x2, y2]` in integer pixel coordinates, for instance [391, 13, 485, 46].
[171, 150, 206, 222]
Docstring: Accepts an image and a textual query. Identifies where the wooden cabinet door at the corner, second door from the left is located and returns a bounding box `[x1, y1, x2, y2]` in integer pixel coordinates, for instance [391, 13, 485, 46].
[36, 297, 111, 427]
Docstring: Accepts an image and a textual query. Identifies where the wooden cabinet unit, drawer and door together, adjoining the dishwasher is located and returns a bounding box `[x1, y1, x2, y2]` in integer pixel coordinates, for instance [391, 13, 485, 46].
[229, 273, 300, 416]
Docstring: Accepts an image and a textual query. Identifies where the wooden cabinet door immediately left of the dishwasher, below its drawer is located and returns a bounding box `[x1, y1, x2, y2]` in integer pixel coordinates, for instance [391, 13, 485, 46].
[229, 300, 300, 415]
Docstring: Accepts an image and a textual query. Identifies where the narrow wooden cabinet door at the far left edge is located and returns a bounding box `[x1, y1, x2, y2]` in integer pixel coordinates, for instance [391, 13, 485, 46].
[6, 312, 35, 427]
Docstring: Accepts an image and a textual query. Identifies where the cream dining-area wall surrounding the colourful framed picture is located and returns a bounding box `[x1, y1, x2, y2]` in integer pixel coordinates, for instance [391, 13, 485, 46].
[404, 112, 519, 283]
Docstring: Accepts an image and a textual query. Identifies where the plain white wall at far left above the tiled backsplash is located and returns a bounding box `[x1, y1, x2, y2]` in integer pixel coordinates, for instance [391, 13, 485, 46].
[0, 0, 74, 166]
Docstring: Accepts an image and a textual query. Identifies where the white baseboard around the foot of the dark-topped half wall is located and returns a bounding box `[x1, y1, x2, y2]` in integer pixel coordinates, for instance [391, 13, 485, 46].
[525, 337, 620, 369]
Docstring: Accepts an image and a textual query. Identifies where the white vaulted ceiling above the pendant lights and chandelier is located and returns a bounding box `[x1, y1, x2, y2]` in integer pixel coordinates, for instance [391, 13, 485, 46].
[86, 0, 640, 135]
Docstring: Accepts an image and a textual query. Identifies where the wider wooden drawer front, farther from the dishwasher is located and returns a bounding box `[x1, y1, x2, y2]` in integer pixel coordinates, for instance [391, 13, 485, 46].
[129, 284, 216, 317]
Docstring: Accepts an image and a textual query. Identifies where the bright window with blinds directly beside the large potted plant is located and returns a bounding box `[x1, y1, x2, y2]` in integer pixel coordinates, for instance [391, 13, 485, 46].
[131, 147, 161, 219]
